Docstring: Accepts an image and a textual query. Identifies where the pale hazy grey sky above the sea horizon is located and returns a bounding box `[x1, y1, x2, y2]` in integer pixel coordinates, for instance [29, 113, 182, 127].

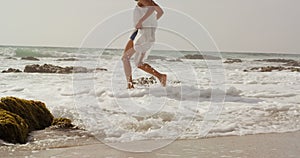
[0, 0, 300, 53]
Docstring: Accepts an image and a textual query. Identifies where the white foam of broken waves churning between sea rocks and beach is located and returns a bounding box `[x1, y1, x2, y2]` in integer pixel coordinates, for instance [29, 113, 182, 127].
[0, 51, 300, 142]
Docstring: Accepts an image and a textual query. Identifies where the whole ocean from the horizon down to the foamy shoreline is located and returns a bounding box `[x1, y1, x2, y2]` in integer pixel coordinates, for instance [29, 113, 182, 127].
[0, 46, 300, 151]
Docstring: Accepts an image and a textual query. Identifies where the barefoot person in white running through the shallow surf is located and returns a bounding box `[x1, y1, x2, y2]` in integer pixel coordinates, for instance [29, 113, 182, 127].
[122, 0, 167, 89]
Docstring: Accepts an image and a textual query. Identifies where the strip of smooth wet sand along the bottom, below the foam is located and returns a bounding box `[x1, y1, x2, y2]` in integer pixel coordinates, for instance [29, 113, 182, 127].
[0, 132, 300, 158]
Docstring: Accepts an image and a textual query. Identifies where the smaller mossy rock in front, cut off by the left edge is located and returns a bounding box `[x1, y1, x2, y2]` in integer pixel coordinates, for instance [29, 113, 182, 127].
[0, 108, 29, 144]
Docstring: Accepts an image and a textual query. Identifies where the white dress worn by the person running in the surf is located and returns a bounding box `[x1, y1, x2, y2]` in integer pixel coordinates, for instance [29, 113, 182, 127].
[133, 6, 157, 66]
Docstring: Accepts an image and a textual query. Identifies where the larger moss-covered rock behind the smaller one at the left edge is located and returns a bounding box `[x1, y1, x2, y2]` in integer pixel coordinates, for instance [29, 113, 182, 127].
[0, 97, 54, 132]
